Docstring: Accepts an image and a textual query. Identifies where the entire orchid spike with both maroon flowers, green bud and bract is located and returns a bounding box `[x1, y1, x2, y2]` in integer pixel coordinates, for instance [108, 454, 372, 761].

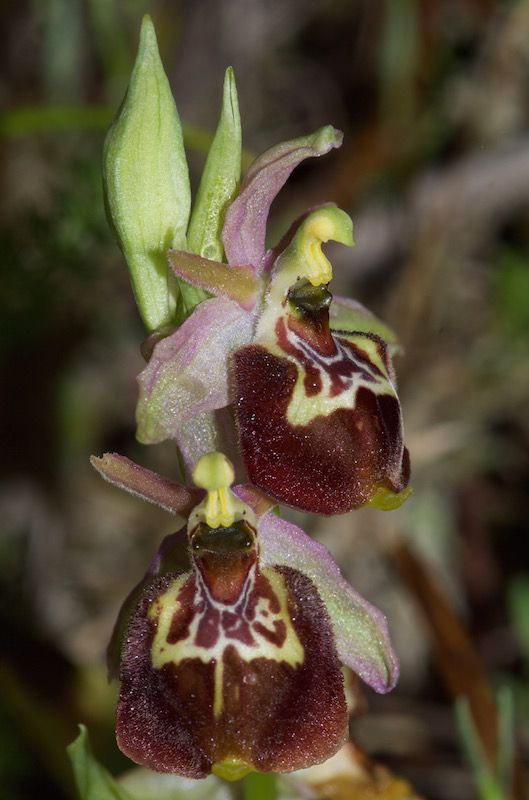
[97, 17, 409, 779]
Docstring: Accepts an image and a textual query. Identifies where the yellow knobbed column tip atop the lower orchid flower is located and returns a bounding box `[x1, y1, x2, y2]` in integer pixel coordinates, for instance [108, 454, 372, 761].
[193, 453, 238, 528]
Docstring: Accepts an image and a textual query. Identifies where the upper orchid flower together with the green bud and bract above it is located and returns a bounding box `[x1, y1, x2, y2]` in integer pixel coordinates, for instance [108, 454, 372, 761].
[104, 18, 409, 514]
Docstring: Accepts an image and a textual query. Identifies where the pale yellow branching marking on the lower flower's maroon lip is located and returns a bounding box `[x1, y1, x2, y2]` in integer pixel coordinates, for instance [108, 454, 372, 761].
[148, 569, 305, 719]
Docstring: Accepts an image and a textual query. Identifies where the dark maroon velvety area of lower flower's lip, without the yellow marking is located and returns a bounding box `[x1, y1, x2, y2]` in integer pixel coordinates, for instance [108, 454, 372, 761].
[117, 568, 347, 778]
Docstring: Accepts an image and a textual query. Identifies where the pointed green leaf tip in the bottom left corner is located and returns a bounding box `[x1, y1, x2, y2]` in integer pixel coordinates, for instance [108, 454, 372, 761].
[66, 725, 134, 800]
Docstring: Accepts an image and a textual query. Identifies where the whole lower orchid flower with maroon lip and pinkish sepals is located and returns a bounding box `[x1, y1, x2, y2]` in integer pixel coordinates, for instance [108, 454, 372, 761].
[92, 453, 398, 779]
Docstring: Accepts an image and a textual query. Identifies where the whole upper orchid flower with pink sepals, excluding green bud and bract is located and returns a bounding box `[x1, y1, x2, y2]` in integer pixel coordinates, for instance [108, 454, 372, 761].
[137, 126, 409, 514]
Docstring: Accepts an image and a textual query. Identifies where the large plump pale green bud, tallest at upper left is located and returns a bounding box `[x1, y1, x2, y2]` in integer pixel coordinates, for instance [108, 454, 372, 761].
[103, 16, 191, 331]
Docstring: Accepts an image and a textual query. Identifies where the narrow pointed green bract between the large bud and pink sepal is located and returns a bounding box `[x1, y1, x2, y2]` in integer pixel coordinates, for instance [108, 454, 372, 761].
[187, 67, 241, 261]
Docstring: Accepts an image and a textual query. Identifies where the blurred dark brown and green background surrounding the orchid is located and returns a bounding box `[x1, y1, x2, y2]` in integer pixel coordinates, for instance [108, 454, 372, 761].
[0, 0, 529, 800]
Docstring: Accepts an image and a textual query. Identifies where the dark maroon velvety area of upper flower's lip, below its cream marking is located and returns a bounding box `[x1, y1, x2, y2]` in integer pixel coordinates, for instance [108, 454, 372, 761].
[233, 345, 409, 514]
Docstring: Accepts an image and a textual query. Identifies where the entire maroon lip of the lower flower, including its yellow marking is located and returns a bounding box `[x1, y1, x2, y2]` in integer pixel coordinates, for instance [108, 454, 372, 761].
[117, 566, 347, 778]
